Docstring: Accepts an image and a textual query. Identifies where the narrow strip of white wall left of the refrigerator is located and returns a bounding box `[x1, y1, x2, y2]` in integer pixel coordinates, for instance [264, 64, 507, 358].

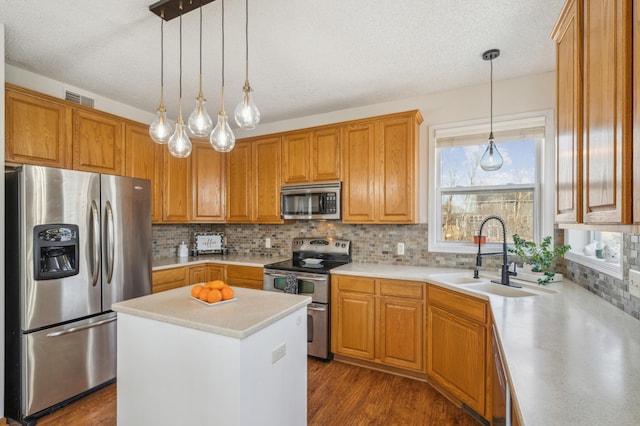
[0, 23, 4, 418]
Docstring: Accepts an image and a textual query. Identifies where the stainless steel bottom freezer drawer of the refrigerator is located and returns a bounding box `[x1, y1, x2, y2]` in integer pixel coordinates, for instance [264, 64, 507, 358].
[21, 312, 117, 417]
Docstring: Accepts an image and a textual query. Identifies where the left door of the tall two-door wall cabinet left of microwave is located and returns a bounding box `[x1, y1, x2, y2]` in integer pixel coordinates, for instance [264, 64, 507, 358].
[226, 141, 253, 223]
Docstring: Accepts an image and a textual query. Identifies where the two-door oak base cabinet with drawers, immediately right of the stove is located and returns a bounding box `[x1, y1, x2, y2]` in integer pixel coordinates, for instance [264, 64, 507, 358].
[331, 275, 426, 373]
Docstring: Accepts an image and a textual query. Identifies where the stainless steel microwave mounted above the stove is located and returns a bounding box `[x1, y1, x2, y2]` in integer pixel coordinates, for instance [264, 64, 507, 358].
[280, 181, 342, 219]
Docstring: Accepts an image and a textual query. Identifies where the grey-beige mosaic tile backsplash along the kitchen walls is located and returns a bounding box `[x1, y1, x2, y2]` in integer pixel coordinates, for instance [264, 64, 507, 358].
[152, 221, 640, 319]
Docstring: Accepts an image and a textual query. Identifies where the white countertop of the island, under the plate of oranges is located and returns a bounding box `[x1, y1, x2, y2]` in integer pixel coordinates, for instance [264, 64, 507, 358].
[113, 286, 311, 339]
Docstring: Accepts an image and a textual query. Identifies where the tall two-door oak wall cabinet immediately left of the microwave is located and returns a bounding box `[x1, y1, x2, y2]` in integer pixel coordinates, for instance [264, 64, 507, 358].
[226, 136, 283, 223]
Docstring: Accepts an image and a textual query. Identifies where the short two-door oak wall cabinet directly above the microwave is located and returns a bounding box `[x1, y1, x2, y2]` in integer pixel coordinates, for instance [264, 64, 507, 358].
[282, 127, 341, 184]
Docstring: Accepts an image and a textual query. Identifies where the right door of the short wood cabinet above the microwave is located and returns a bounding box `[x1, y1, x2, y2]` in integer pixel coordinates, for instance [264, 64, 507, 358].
[311, 127, 341, 182]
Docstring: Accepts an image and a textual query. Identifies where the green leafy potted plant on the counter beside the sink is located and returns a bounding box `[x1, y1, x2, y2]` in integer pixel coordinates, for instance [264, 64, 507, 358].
[508, 234, 571, 285]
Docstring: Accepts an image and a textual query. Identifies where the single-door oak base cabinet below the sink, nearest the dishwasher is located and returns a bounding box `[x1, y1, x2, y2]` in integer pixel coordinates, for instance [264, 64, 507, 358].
[426, 286, 491, 417]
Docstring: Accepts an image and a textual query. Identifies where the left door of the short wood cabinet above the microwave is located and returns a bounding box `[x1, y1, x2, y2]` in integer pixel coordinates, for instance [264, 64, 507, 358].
[282, 132, 312, 183]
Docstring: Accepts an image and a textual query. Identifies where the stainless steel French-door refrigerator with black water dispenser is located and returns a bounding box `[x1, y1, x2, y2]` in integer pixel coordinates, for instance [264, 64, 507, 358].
[5, 165, 151, 424]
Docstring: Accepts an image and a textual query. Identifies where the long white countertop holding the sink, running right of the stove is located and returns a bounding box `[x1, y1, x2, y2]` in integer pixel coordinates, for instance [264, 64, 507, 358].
[331, 263, 640, 425]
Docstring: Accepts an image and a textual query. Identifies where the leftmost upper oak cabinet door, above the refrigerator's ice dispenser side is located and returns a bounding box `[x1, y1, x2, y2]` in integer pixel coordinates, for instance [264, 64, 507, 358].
[4, 88, 72, 169]
